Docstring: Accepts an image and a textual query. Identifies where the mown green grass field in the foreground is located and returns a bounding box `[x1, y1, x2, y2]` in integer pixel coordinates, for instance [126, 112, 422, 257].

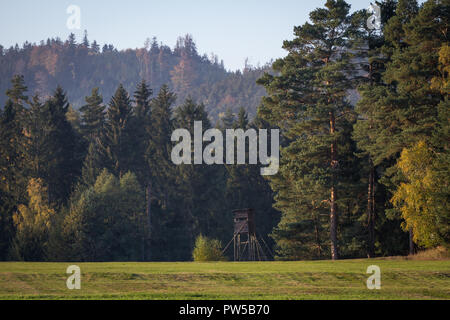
[0, 259, 450, 299]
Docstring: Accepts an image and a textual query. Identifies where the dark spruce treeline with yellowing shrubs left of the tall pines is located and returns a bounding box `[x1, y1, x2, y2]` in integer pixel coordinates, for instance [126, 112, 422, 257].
[0, 76, 278, 261]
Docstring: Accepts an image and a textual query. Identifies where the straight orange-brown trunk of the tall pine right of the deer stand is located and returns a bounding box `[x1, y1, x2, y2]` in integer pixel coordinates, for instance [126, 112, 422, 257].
[330, 112, 339, 260]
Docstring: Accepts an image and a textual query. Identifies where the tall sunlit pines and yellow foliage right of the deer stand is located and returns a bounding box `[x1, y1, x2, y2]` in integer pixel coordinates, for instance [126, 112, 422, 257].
[258, 0, 450, 259]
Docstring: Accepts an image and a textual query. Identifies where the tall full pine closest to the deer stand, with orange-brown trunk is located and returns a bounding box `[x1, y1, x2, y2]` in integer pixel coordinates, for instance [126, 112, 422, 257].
[259, 0, 361, 259]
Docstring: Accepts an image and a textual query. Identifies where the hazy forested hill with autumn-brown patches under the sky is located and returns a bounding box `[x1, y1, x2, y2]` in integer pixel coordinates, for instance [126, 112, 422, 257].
[0, 34, 268, 119]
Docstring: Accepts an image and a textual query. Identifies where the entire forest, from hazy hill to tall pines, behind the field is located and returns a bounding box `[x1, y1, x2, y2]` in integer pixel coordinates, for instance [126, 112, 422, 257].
[0, 0, 450, 261]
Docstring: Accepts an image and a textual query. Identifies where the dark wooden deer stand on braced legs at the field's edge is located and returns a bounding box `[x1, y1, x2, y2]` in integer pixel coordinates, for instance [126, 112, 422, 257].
[223, 209, 271, 261]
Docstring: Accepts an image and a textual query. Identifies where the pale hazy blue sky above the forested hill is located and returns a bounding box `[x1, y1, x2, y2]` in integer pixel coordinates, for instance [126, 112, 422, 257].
[0, 0, 384, 70]
